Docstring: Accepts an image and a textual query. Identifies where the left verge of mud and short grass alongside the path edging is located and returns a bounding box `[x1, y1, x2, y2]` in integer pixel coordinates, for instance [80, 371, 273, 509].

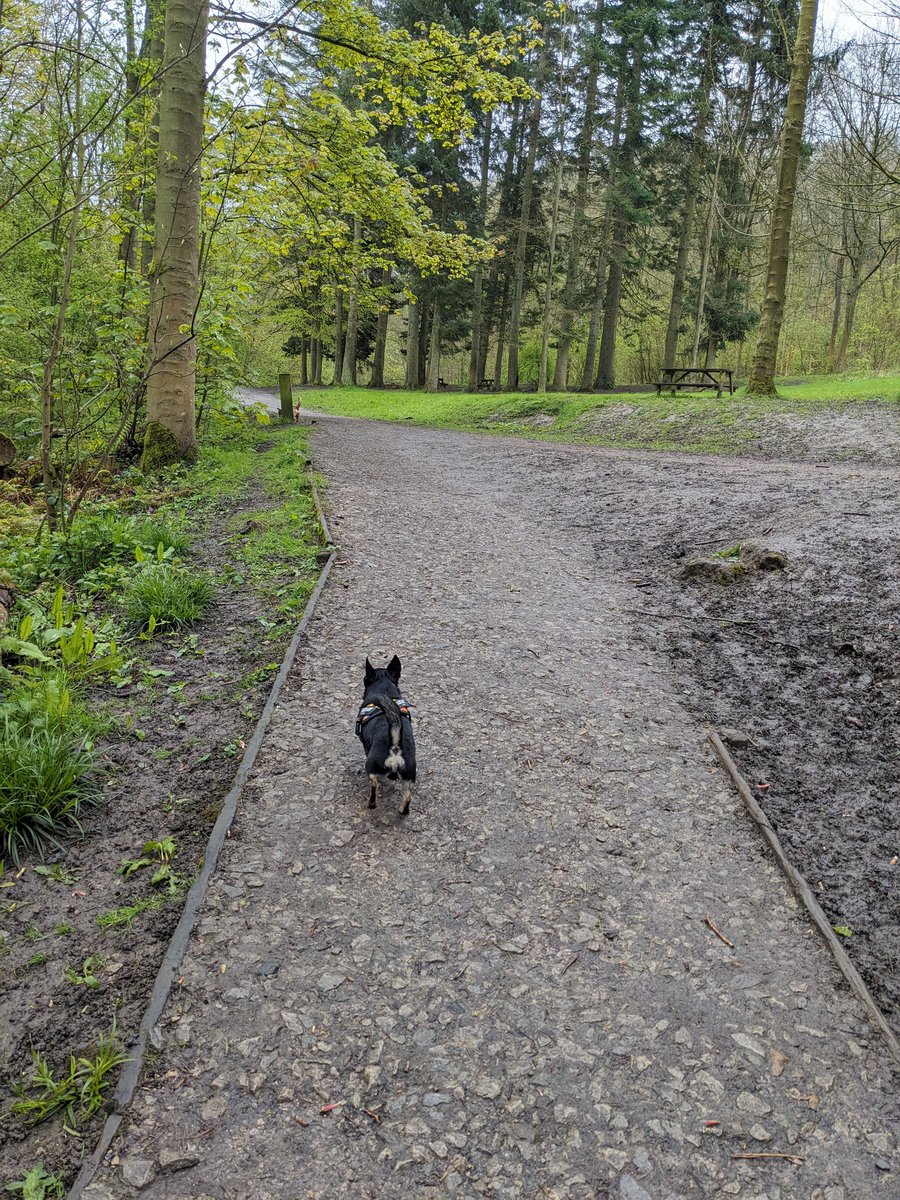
[0, 425, 320, 1200]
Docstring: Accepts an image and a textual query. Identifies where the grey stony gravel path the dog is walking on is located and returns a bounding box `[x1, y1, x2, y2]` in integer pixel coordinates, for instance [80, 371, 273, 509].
[82, 419, 900, 1200]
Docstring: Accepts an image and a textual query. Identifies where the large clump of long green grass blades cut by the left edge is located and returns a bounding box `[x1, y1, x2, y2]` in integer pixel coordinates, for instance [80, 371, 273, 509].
[0, 710, 94, 863]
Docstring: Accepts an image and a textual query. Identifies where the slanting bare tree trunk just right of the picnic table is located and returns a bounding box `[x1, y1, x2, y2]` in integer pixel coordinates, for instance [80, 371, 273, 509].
[746, 0, 818, 396]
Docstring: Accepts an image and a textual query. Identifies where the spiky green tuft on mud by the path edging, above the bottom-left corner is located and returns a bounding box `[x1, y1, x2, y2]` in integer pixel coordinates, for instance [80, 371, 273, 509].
[12, 1022, 127, 1136]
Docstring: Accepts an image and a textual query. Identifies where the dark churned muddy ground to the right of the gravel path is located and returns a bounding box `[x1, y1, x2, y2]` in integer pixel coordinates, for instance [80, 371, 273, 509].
[535, 441, 900, 1030]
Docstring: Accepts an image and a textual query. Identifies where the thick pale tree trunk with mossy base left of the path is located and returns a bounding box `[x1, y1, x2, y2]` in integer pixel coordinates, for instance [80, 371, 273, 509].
[142, 0, 209, 470]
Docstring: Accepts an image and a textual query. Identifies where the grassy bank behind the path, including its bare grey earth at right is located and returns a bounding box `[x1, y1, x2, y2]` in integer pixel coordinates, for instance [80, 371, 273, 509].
[302, 376, 900, 464]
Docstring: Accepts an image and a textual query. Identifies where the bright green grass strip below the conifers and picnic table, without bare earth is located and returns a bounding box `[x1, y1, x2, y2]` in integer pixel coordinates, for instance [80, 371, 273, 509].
[302, 376, 900, 454]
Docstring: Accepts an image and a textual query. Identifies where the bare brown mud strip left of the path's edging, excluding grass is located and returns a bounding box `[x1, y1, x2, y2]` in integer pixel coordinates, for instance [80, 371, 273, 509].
[0, 456, 317, 1187]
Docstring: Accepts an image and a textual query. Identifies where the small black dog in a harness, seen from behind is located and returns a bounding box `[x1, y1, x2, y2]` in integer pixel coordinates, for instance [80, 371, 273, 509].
[356, 654, 415, 816]
